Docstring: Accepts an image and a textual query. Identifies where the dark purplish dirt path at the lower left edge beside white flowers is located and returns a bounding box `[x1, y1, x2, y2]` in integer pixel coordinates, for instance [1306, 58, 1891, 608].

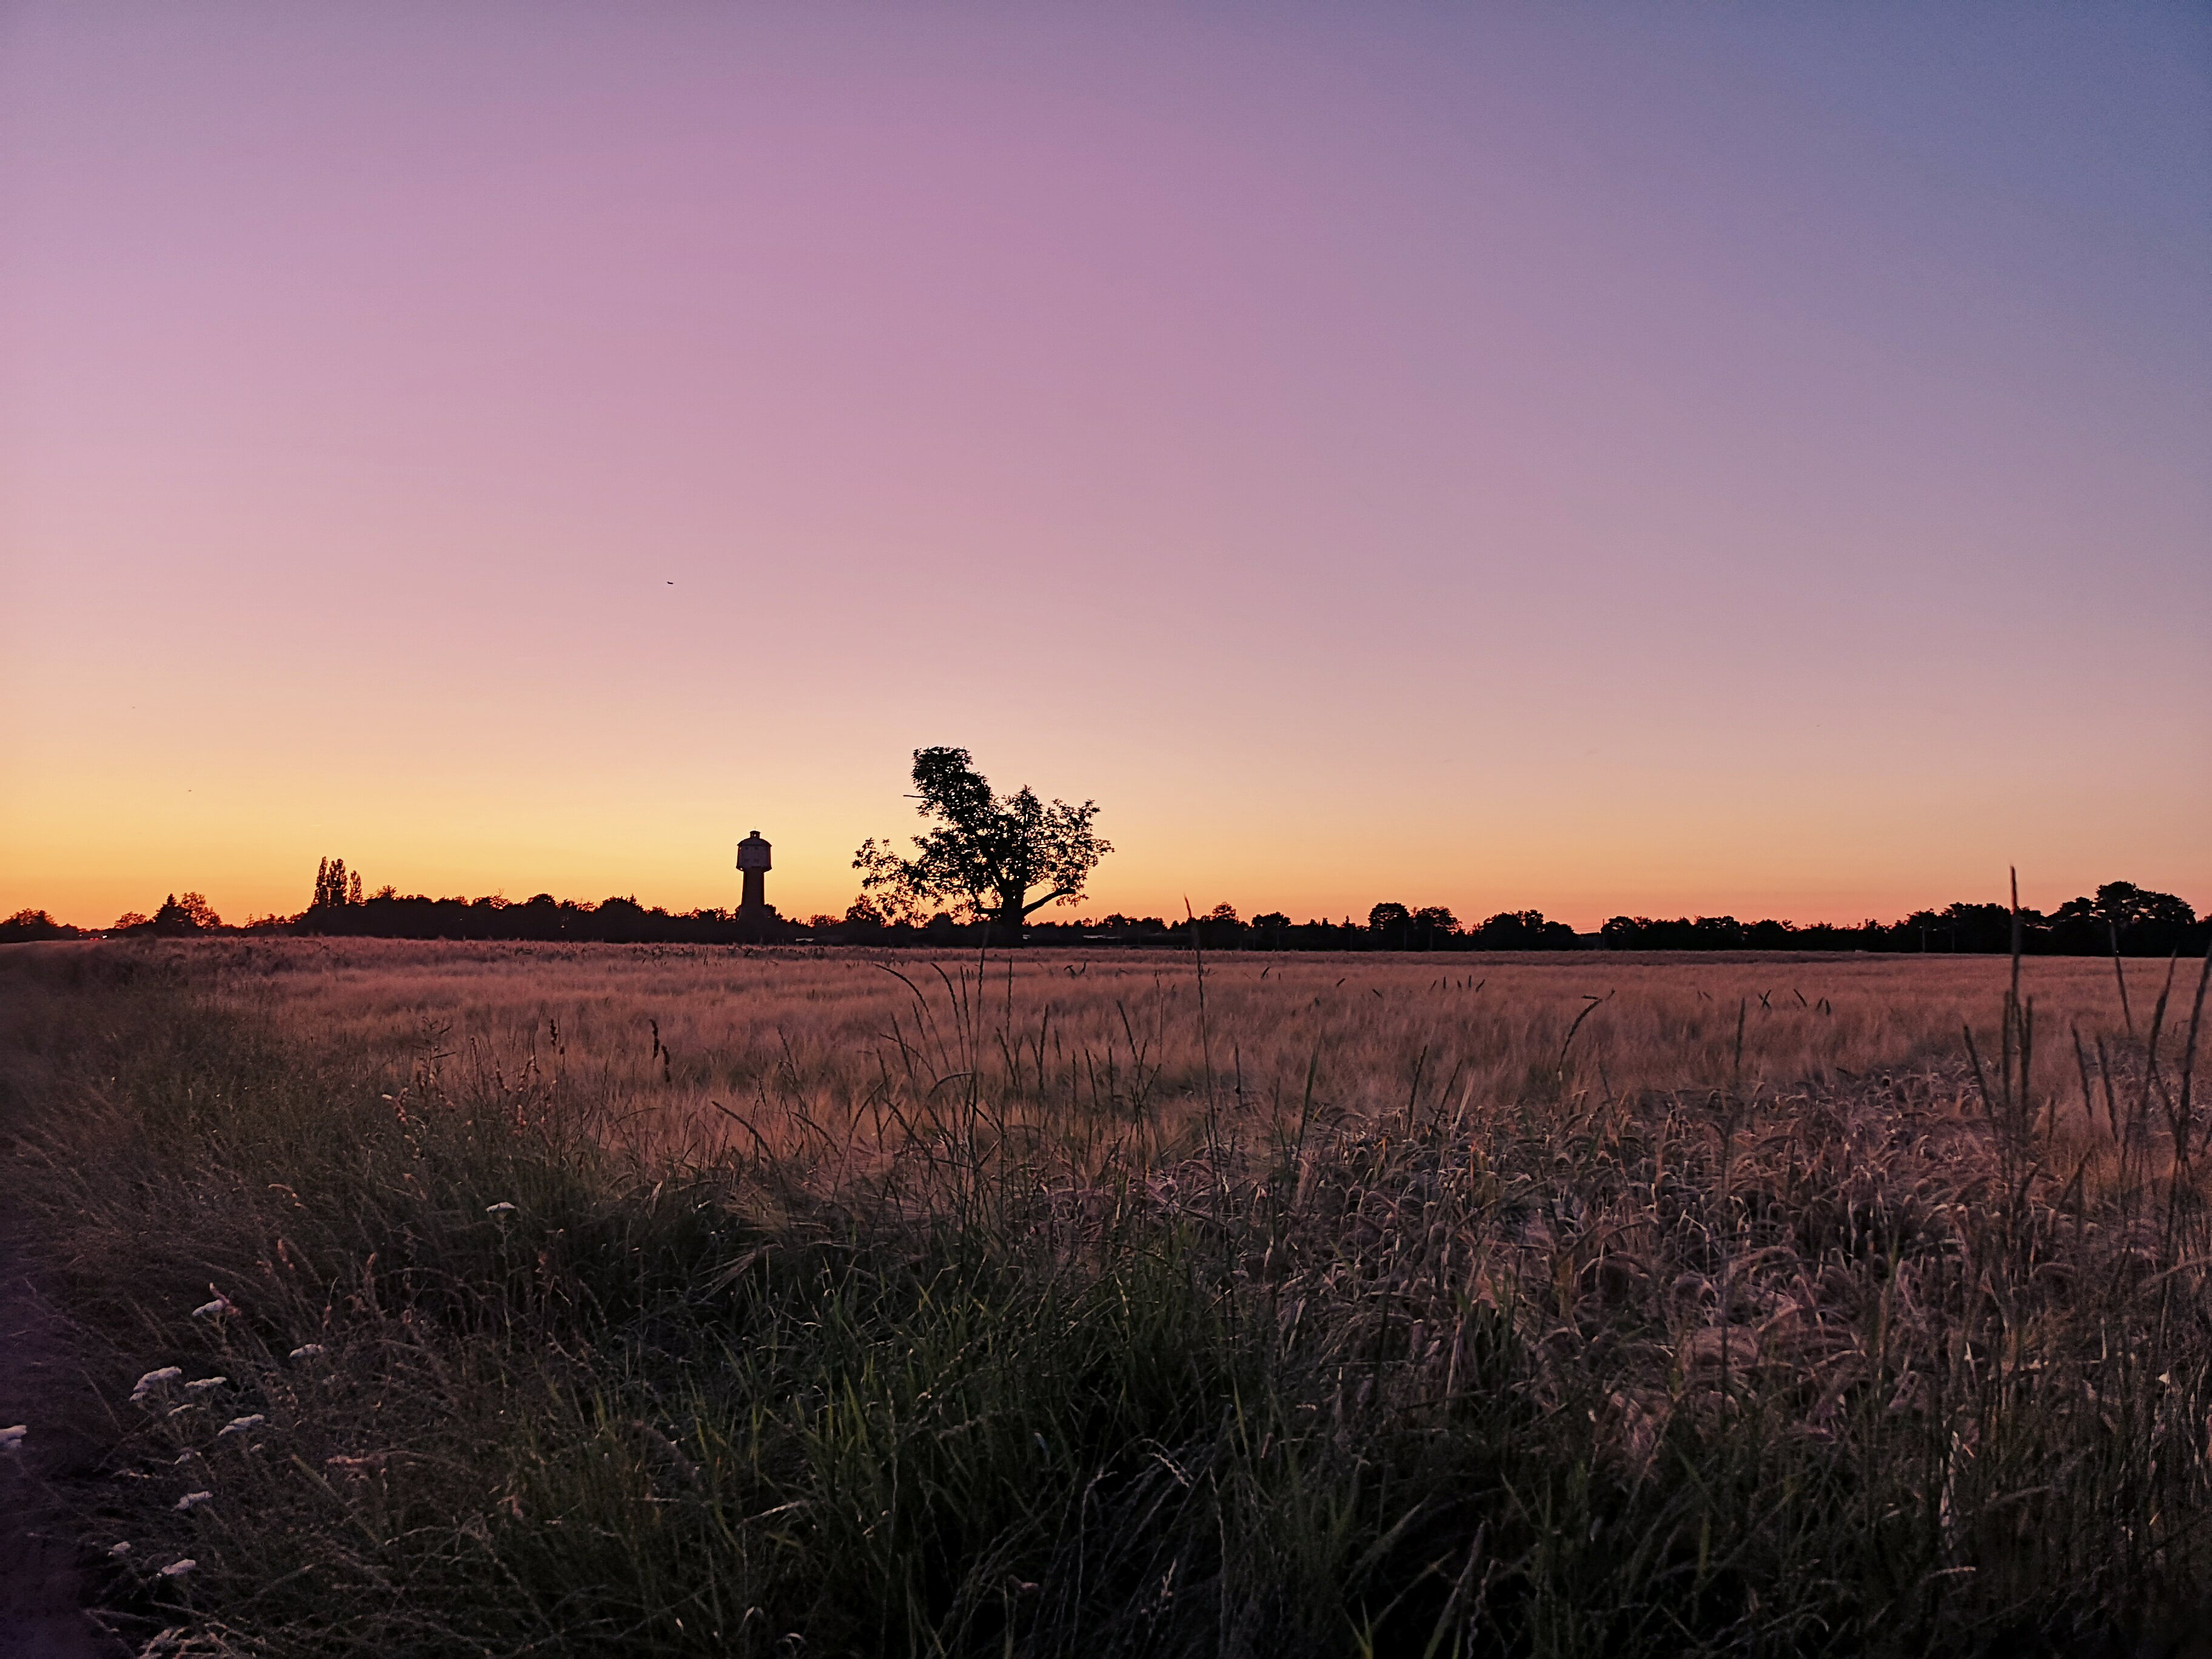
[0, 1243, 124, 1659]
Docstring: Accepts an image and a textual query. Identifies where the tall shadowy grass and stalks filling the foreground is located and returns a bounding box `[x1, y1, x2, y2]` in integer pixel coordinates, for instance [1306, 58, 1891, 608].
[0, 947, 2212, 1657]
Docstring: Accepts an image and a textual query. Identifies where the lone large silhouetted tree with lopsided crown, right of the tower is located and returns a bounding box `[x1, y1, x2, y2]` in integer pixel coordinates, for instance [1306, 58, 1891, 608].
[851, 748, 1113, 945]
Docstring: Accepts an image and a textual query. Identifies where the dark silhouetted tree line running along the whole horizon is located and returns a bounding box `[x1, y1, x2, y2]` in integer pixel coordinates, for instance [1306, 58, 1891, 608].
[0, 876, 2212, 956]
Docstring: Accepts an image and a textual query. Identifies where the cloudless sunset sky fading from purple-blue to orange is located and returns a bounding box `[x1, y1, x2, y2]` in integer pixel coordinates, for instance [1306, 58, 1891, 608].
[0, 0, 2212, 927]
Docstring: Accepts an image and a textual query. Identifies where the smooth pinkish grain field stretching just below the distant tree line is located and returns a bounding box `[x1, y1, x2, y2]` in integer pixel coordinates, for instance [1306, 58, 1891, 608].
[199, 940, 2150, 1133]
